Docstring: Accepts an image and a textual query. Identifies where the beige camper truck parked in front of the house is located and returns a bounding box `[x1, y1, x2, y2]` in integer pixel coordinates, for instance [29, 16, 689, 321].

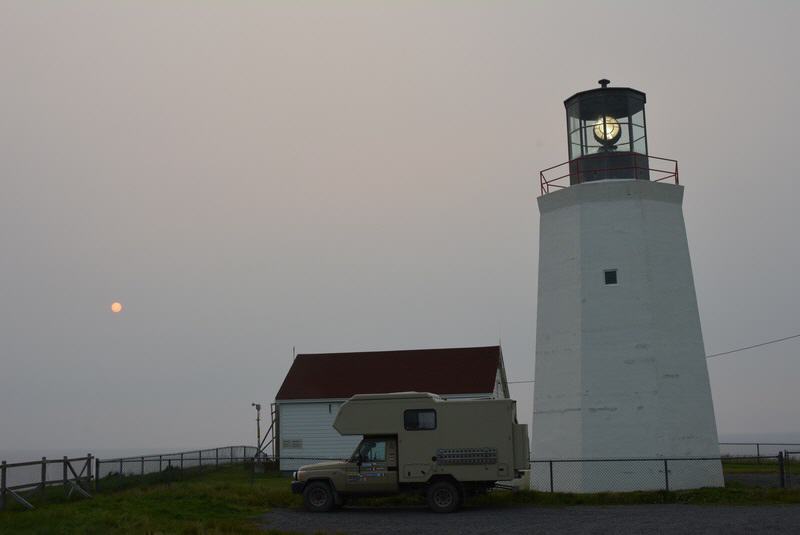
[292, 392, 530, 513]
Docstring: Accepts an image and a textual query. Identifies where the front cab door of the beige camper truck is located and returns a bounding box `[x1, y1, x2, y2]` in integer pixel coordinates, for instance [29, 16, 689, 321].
[344, 437, 398, 494]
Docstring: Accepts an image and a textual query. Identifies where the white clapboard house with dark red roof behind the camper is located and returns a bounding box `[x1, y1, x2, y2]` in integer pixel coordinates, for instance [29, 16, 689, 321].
[275, 346, 509, 471]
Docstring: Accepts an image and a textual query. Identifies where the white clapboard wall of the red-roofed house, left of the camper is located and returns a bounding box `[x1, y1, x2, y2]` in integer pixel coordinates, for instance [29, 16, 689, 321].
[278, 401, 361, 470]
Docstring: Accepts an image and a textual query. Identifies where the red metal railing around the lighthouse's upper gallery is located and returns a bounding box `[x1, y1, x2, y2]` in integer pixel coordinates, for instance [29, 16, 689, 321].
[539, 154, 680, 195]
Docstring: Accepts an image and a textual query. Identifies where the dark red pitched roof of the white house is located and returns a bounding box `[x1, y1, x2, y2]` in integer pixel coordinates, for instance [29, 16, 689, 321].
[275, 346, 501, 400]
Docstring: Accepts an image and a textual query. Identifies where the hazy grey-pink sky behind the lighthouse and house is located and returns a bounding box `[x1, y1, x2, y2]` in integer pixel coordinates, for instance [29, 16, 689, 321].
[0, 0, 800, 451]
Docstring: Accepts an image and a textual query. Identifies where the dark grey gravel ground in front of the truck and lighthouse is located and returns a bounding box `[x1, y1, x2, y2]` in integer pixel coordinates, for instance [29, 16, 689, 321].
[262, 505, 800, 535]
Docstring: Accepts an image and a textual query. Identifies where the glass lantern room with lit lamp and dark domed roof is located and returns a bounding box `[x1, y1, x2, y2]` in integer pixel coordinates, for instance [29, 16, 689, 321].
[564, 79, 650, 184]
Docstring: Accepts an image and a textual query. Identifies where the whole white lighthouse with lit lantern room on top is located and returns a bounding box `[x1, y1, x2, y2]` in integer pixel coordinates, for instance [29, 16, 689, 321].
[531, 80, 723, 492]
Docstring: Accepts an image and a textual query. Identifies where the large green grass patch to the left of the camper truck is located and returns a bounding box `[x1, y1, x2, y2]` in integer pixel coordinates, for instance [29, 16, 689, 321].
[0, 465, 300, 535]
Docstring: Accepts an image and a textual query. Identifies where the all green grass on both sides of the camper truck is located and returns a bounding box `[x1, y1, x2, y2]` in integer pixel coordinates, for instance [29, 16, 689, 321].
[0, 464, 800, 535]
